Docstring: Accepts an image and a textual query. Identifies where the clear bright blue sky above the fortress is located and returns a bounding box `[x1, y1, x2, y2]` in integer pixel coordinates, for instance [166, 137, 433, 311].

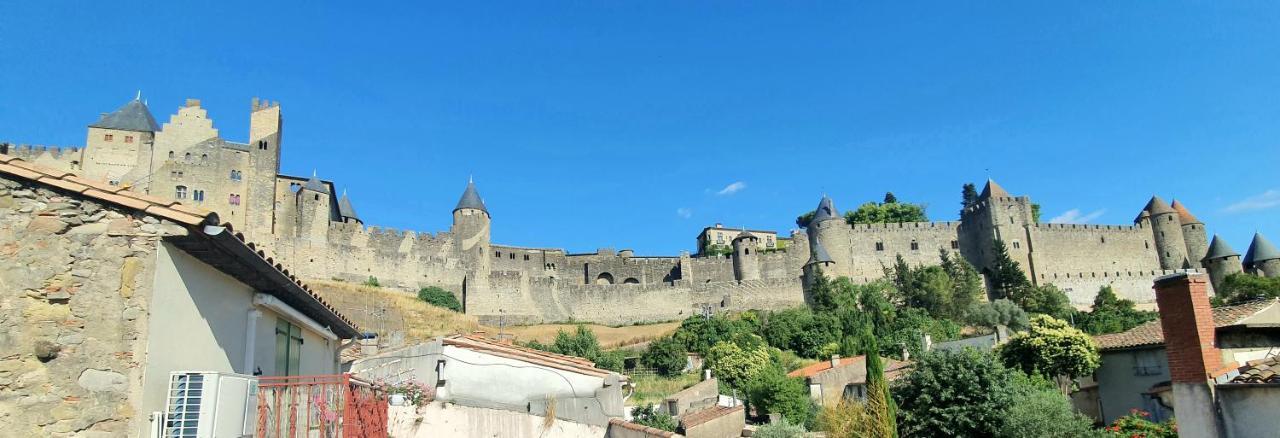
[0, 1, 1280, 255]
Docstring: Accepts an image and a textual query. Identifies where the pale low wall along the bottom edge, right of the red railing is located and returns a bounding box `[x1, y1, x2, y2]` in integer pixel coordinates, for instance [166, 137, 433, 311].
[387, 402, 608, 438]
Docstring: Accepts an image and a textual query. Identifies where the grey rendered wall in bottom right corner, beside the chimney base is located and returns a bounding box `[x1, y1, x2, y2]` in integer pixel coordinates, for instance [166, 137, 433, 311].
[1215, 383, 1280, 438]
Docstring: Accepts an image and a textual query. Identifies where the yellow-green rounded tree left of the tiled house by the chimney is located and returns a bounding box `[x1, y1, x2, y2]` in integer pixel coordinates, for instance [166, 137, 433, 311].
[997, 315, 1102, 378]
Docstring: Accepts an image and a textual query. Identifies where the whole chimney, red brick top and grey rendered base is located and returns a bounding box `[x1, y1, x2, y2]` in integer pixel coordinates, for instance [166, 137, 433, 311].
[1155, 272, 1225, 438]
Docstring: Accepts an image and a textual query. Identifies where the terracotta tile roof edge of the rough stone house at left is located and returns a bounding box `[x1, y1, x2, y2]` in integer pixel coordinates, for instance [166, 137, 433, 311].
[0, 154, 360, 333]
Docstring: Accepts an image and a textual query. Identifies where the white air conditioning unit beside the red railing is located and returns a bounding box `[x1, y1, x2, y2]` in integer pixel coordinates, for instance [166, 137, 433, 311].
[160, 371, 257, 438]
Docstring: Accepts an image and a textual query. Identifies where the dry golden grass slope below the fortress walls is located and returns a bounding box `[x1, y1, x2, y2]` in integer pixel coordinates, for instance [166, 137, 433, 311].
[307, 279, 680, 348]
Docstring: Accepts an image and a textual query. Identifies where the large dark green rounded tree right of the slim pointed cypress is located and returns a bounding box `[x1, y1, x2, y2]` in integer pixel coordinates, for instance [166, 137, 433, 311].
[892, 348, 1018, 437]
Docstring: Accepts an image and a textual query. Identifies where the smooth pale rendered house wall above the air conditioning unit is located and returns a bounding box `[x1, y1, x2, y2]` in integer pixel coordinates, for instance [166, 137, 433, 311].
[140, 243, 338, 430]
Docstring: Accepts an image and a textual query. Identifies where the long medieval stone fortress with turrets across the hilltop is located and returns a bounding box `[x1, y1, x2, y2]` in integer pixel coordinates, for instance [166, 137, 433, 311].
[10, 94, 1280, 324]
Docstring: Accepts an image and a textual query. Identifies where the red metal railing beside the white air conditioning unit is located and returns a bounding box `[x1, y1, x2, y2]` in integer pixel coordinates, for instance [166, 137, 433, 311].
[255, 374, 387, 438]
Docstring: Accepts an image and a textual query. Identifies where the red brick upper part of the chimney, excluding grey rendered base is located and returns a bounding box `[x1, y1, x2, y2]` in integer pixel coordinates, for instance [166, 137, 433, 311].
[1155, 273, 1224, 383]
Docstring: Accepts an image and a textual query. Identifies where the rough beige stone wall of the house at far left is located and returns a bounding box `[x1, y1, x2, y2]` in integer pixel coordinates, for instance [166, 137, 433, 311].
[0, 179, 170, 437]
